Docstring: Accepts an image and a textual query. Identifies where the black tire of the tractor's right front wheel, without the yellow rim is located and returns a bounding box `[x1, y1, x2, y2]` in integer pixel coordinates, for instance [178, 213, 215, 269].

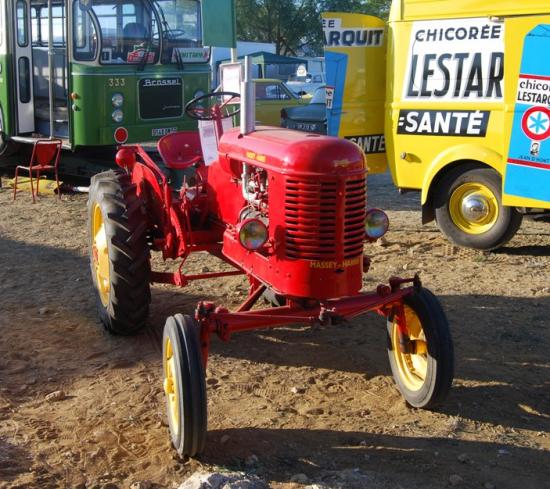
[387, 288, 454, 409]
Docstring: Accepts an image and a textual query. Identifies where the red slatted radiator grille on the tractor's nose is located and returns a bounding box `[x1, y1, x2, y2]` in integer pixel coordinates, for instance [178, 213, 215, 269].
[285, 178, 366, 261]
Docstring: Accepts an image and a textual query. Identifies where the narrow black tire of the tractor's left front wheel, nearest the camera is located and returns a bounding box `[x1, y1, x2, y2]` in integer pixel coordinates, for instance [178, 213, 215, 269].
[162, 314, 207, 457]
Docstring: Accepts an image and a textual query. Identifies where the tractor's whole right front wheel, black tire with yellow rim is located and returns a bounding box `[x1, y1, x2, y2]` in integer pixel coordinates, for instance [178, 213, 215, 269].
[387, 289, 454, 409]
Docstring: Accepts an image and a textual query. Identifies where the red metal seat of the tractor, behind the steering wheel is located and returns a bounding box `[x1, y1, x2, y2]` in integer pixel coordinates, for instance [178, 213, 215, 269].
[157, 131, 202, 170]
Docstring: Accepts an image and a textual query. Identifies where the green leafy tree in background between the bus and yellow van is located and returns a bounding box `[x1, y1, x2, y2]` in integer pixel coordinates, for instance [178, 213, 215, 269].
[237, 0, 391, 56]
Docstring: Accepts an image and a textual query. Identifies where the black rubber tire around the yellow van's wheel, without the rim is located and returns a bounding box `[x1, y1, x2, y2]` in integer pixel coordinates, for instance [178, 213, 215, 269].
[433, 164, 523, 251]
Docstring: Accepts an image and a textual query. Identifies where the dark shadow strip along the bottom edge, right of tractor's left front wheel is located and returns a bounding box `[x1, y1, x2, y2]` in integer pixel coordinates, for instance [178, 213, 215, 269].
[201, 428, 548, 489]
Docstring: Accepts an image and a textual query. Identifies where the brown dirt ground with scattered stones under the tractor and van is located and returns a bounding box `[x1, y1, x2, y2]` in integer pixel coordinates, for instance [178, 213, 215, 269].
[0, 176, 550, 489]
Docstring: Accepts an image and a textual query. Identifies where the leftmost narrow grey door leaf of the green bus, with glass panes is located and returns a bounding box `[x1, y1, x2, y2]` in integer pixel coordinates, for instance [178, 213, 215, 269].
[13, 0, 34, 134]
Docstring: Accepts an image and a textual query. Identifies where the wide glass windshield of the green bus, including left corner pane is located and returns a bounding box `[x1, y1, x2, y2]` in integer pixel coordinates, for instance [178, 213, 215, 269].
[73, 0, 202, 64]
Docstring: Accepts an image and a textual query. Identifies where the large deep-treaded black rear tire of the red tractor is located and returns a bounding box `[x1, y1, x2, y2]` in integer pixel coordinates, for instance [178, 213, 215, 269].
[88, 170, 151, 335]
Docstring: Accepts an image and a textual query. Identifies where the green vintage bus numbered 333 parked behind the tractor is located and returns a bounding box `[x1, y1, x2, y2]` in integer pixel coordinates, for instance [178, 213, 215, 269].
[0, 0, 230, 173]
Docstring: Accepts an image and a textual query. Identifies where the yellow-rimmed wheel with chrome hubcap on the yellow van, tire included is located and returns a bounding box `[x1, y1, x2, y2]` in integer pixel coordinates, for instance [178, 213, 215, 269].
[434, 167, 523, 250]
